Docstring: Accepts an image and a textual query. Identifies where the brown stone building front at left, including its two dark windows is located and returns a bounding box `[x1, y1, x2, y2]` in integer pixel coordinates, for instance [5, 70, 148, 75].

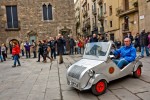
[0, 0, 75, 44]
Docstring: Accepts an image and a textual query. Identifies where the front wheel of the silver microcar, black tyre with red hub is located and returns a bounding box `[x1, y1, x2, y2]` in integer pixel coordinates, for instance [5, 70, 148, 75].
[91, 80, 107, 96]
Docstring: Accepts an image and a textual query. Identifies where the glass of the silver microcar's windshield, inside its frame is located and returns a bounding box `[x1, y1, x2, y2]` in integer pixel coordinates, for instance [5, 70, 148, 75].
[84, 42, 110, 58]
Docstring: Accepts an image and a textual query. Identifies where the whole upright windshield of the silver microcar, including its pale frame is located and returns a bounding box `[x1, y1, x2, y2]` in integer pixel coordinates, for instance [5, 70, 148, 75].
[83, 42, 111, 61]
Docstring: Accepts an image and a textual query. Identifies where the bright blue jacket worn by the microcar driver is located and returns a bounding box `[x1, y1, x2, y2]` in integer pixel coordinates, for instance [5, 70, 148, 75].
[114, 45, 136, 62]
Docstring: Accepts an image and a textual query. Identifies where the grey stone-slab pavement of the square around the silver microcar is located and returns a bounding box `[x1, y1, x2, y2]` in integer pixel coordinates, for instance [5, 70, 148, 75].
[0, 55, 150, 100]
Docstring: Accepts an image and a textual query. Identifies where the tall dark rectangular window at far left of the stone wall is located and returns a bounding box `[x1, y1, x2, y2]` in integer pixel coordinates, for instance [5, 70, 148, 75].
[6, 6, 18, 28]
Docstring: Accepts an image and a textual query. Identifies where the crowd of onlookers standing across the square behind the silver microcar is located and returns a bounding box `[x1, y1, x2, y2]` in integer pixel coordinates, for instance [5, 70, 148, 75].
[0, 30, 150, 67]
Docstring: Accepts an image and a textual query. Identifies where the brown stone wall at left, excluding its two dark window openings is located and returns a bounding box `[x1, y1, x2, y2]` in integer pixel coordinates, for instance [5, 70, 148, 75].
[0, 0, 75, 43]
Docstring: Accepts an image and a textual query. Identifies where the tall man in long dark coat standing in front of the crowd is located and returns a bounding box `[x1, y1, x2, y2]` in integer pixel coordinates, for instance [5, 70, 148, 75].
[57, 34, 64, 64]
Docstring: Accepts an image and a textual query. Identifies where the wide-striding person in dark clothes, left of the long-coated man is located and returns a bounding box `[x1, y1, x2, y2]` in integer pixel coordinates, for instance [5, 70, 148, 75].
[43, 40, 52, 63]
